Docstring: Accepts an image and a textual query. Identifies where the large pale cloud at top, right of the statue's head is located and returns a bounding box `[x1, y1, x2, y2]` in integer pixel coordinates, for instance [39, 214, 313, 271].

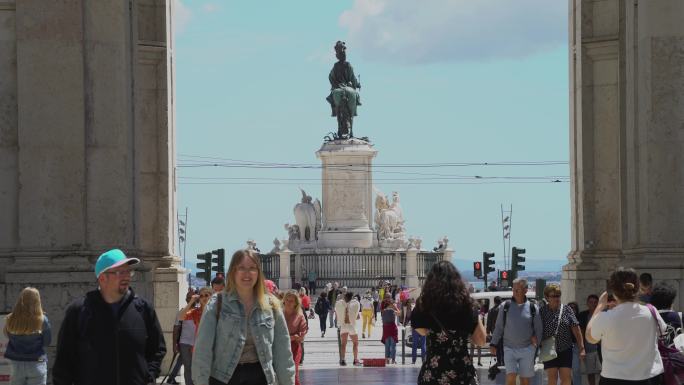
[339, 0, 568, 64]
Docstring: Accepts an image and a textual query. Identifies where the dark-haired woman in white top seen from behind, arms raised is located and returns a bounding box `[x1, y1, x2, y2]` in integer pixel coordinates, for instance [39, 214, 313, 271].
[586, 267, 665, 385]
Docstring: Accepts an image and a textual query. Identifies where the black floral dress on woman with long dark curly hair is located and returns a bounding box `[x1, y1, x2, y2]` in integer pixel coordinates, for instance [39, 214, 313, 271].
[414, 313, 478, 385]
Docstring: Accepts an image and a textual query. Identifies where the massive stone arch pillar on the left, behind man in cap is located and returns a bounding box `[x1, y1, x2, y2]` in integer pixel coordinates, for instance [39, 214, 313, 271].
[0, 0, 186, 368]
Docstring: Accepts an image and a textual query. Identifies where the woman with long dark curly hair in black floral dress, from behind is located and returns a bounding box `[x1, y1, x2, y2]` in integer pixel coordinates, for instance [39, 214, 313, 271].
[411, 261, 486, 384]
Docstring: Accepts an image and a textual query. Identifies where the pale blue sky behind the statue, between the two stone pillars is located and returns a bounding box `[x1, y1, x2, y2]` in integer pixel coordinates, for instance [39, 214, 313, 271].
[174, 0, 570, 270]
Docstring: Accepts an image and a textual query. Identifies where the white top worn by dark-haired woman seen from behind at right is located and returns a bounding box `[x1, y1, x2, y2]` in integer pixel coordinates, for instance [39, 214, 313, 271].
[589, 302, 666, 381]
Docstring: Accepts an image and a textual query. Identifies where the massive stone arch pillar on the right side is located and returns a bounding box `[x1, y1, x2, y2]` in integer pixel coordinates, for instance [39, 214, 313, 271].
[562, 0, 684, 307]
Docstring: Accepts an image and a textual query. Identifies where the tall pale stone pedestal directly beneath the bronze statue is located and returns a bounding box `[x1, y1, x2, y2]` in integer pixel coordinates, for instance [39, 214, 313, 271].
[316, 139, 377, 249]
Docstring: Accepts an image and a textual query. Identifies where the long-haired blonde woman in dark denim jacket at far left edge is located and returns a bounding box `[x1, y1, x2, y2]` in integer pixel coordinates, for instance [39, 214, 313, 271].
[4, 287, 52, 385]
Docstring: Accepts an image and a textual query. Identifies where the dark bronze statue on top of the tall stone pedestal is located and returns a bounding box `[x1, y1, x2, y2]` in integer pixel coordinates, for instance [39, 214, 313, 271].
[326, 41, 361, 138]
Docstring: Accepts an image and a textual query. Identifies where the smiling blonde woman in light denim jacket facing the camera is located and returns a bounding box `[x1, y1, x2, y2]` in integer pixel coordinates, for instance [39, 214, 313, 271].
[192, 250, 295, 385]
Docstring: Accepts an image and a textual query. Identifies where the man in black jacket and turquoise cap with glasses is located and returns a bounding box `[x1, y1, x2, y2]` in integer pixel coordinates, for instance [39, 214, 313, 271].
[52, 249, 166, 385]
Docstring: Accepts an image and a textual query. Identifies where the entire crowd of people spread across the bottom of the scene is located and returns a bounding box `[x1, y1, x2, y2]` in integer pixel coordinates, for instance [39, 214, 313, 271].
[4, 249, 683, 385]
